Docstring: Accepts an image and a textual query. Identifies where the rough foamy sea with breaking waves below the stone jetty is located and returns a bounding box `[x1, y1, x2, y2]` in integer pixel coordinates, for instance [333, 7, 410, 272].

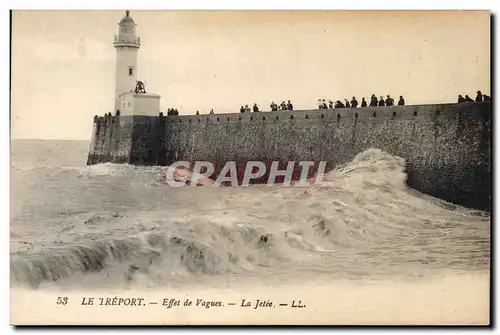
[10, 140, 490, 289]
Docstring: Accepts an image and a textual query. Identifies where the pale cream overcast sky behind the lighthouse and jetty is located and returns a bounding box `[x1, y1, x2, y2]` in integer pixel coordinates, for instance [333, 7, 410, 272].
[11, 11, 490, 140]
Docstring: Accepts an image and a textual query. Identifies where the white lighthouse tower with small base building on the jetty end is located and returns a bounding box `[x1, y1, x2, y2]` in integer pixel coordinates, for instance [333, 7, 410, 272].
[113, 10, 160, 116]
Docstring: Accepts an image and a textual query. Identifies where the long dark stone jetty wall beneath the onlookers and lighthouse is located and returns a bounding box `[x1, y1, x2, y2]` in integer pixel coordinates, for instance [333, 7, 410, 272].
[87, 103, 491, 211]
